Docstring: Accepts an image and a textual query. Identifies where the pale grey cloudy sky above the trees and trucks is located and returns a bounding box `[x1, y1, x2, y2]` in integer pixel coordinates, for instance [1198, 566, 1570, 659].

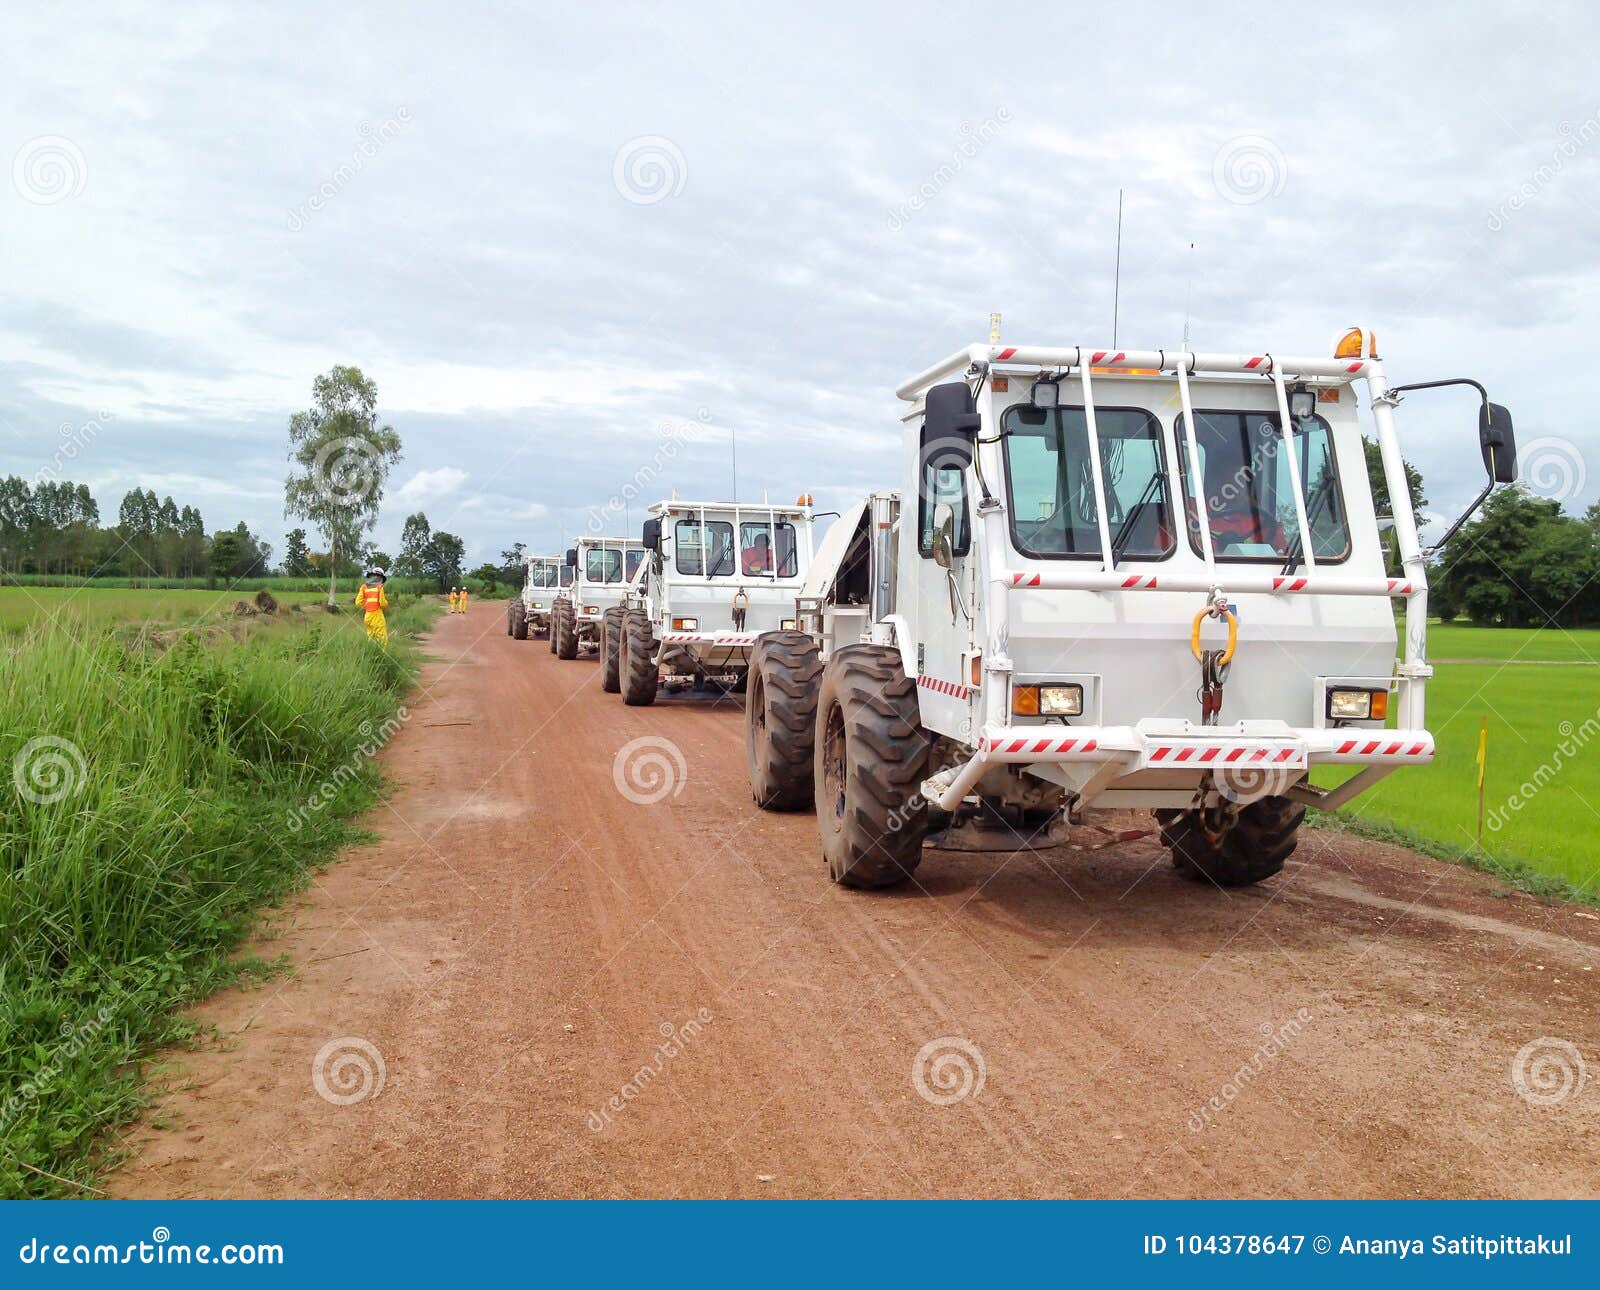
[0, 3, 1600, 563]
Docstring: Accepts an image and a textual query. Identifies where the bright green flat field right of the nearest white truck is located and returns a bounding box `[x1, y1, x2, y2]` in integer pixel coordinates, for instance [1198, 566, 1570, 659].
[1317, 624, 1600, 901]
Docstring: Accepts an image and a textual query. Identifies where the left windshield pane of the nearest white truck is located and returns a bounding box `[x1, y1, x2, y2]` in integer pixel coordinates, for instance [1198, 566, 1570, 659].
[1000, 407, 1173, 560]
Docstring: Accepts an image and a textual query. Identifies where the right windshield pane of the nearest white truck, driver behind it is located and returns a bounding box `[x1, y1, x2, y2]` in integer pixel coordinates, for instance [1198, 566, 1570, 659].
[1178, 411, 1350, 562]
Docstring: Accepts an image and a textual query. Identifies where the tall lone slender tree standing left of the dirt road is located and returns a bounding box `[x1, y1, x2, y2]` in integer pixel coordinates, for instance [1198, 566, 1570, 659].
[283, 367, 400, 610]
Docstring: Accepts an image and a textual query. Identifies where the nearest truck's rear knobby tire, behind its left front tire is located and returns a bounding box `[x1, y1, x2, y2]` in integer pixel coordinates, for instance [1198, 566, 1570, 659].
[744, 632, 822, 811]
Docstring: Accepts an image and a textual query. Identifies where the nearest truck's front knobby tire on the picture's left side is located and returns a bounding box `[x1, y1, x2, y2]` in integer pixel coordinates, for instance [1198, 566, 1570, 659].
[813, 645, 931, 887]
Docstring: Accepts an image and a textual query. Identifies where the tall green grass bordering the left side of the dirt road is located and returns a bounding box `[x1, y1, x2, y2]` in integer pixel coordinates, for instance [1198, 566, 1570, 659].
[0, 602, 437, 1197]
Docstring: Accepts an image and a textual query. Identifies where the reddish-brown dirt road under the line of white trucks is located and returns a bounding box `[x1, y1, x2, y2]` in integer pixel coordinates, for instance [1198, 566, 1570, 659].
[110, 603, 1600, 1197]
